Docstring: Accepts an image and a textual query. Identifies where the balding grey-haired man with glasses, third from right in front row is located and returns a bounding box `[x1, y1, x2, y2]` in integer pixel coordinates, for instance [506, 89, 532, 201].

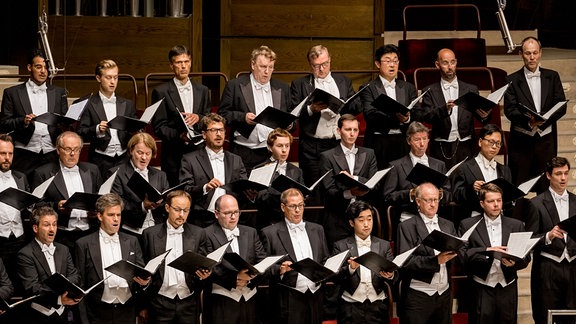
[397, 182, 457, 324]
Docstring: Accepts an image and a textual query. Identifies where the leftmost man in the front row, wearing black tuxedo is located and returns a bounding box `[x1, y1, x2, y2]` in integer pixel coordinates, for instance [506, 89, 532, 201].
[18, 206, 81, 323]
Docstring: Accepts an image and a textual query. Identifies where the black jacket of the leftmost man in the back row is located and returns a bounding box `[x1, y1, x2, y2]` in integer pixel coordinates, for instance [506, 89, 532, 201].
[0, 82, 68, 145]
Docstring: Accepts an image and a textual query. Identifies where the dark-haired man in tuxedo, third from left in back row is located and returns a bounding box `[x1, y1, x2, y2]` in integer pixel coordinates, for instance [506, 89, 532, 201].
[152, 45, 211, 187]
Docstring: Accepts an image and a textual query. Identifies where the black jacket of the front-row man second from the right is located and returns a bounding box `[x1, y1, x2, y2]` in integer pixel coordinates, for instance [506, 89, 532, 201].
[458, 216, 530, 283]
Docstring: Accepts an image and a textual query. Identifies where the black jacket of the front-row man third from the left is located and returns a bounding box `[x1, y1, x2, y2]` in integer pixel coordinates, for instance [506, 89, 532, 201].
[142, 222, 206, 295]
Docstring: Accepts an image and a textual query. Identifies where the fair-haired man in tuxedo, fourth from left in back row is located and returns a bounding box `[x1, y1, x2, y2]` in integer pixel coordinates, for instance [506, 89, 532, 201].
[218, 45, 291, 171]
